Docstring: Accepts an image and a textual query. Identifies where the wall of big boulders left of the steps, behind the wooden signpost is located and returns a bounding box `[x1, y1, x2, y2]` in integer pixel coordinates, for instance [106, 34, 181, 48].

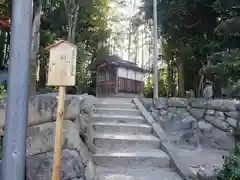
[0, 94, 98, 180]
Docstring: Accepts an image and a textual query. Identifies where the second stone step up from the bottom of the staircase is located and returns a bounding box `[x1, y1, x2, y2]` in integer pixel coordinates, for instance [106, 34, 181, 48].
[93, 148, 170, 168]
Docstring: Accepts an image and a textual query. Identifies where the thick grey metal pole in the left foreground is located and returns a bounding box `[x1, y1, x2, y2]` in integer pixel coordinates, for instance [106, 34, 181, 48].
[2, 0, 32, 180]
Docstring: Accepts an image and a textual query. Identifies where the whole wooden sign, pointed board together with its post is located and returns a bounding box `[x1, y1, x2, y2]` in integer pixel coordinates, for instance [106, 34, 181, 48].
[47, 40, 77, 180]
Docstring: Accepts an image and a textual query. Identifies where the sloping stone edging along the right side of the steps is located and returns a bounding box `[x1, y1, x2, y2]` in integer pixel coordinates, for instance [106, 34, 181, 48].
[133, 98, 194, 180]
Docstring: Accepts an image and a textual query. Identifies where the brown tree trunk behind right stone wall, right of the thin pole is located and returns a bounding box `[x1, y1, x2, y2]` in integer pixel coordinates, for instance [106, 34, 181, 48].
[177, 60, 185, 97]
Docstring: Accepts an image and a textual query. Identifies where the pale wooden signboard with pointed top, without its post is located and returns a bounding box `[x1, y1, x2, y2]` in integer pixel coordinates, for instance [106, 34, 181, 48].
[47, 40, 77, 86]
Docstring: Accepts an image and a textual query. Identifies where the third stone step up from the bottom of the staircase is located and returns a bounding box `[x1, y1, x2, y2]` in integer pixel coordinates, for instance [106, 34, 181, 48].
[94, 133, 161, 150]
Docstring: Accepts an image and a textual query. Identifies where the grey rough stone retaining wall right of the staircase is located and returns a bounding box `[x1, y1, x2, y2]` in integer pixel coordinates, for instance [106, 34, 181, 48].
[141, 98, 239, 150]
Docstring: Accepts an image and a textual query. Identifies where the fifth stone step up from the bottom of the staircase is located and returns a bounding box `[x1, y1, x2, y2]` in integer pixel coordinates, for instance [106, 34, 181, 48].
[92, 114, 146, 123]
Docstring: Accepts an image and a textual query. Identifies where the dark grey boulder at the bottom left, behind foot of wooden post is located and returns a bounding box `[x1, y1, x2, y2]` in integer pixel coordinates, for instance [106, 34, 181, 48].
[27, 150, 85, 180]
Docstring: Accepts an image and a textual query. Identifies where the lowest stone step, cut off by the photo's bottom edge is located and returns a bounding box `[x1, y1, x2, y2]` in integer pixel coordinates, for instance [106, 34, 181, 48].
[96, 166, 182, 180]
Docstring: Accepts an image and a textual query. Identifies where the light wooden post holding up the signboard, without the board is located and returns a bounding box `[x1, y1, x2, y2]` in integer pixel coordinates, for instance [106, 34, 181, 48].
[52, 86, 65, 180]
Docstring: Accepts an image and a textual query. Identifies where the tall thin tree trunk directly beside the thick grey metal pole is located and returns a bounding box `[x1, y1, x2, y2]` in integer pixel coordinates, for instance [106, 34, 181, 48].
[28, 1, 42, 96]
